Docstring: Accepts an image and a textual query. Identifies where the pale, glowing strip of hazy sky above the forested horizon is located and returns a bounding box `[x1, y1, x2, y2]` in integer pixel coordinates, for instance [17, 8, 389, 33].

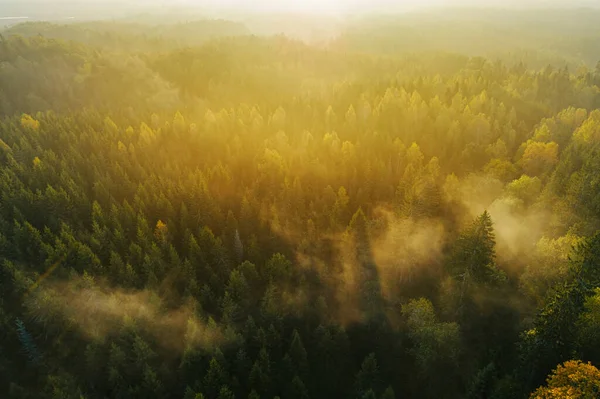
[0, 0, 600, 19]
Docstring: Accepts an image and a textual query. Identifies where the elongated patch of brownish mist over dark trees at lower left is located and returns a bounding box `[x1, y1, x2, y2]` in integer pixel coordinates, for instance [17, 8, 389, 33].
[25, 277, 226, 354]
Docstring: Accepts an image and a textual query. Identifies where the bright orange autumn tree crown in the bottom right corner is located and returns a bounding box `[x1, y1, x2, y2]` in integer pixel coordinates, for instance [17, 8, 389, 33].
[530, 360, 600, 399]
